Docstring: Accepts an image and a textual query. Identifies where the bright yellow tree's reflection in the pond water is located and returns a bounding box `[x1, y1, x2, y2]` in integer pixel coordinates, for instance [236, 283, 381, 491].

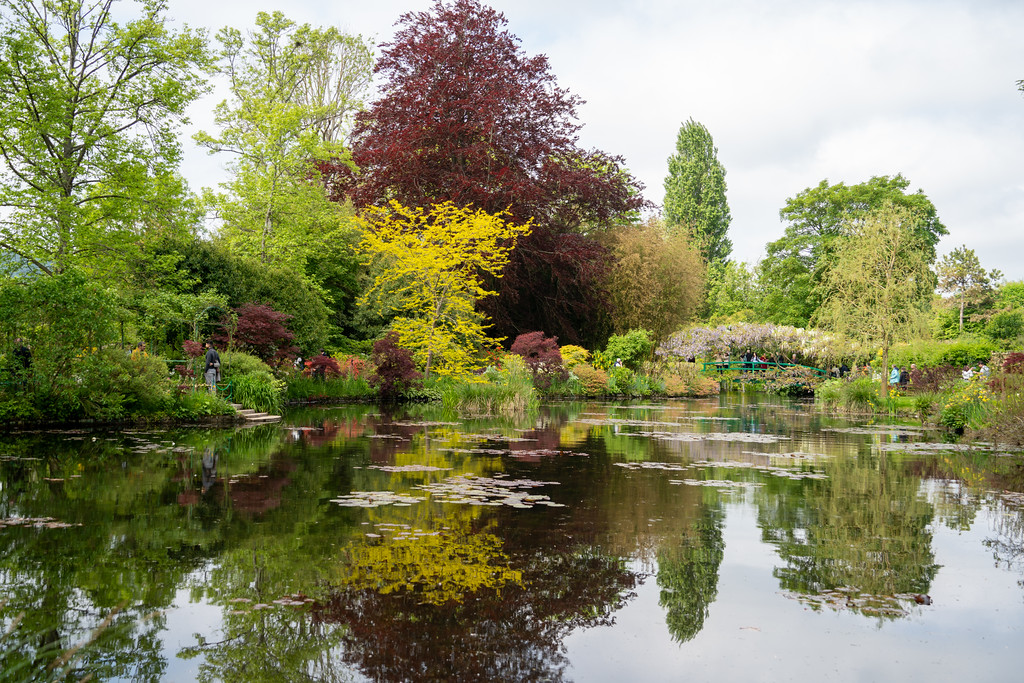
[334, 529, 522, 605]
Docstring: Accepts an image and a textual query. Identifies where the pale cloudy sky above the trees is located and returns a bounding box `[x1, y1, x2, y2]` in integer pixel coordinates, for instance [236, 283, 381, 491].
[169, 0, 1024, 280]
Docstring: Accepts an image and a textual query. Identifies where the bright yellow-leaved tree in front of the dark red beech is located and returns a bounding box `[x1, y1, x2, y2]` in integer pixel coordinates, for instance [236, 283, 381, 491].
[359, 201, 529, 376]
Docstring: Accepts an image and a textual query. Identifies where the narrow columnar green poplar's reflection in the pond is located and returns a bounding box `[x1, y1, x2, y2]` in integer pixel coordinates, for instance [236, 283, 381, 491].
[657, 506, 725, 643]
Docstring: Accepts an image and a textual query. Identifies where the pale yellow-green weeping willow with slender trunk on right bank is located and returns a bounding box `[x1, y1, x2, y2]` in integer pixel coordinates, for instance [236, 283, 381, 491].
[816, 206, 934, 397]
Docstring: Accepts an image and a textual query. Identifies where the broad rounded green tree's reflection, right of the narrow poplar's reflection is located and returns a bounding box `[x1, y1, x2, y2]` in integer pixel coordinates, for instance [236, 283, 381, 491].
[760, 450, 938, 615]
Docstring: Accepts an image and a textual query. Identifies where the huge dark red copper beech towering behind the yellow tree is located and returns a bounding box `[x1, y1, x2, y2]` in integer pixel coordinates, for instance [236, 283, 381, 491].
[324, 0, 644, 342]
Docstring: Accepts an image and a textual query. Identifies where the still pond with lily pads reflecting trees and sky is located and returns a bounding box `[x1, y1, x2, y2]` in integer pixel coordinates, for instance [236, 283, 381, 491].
[0, 394, 1024, 683]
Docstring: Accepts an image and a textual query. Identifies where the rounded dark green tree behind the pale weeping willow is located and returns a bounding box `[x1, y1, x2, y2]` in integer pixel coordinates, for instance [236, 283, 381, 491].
[759, 174, 948, 327]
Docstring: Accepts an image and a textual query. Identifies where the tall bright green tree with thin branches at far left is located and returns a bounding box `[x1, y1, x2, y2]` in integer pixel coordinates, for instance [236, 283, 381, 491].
[0, 0, 209, 274]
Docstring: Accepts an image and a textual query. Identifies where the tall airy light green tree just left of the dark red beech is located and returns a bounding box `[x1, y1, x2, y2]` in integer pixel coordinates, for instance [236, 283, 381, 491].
[196, 11, 373, 271]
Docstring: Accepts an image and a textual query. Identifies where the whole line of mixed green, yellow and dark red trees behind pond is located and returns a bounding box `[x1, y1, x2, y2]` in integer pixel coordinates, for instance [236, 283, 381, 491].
[0, 0, 1024, 395]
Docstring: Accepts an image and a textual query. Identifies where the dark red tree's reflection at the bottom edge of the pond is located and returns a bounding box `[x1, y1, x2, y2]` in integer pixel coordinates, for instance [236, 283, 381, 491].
[313, 549, 639, 681]
